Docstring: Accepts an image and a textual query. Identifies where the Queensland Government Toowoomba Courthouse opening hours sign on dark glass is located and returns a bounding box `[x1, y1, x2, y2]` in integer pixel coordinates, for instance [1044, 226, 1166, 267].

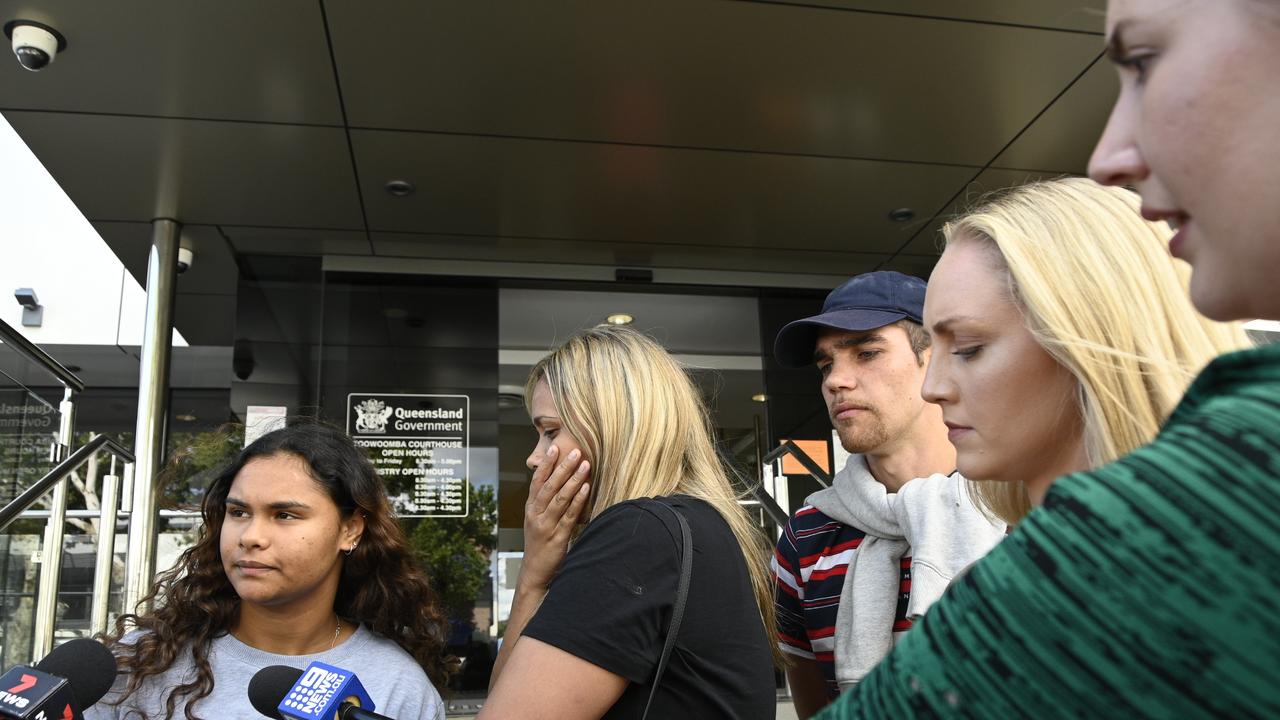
[347, 392, 471, 518]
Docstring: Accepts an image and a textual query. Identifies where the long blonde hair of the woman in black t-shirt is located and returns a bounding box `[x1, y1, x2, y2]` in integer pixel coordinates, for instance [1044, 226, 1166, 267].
[525, 325, 783, 664]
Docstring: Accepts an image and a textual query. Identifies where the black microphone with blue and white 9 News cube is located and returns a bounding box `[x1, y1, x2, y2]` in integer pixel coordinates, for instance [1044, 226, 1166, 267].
[248, 662, 393, 720]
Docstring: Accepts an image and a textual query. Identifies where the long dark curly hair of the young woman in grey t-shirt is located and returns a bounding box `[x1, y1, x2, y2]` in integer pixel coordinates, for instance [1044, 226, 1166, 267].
[105, 424, 452, 720]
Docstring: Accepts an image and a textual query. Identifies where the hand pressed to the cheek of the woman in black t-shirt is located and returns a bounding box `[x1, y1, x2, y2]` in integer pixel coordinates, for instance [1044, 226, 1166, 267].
[518, 446, 591, 591]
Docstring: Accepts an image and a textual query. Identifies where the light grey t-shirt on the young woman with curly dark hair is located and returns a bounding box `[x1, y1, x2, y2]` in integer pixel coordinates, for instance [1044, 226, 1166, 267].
[84, 625, 444, 720]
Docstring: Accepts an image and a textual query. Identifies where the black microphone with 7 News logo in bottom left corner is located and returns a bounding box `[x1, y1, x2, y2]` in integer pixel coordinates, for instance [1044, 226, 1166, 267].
[0, 638, 115, 720]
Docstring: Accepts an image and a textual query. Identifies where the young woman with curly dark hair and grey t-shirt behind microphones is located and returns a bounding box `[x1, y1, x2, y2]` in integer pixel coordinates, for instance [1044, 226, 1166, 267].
[86, 425, 447, 720]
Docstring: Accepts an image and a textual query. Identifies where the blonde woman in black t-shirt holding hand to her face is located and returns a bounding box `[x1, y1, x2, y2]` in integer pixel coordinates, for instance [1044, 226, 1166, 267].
[480, 325, 778, 719]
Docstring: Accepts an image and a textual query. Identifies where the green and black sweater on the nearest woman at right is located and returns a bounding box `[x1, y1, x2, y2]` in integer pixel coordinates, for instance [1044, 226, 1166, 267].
[819, 346, 1280, 720]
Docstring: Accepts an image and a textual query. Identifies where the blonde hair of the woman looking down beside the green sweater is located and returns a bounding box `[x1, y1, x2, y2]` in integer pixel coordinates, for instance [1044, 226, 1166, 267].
[942, 178, 1249, 524]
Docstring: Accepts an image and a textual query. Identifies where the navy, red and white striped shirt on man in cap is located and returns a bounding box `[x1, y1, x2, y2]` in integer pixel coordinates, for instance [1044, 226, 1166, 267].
[771, 505, 911, 698]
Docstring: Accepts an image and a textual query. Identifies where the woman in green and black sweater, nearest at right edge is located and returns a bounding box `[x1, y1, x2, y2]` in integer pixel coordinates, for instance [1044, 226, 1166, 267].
[823, 0, 1280, 719]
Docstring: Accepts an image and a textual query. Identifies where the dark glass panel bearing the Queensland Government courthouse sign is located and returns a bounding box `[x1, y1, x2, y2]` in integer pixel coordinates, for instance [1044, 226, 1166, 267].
[320, 273, 499, 707]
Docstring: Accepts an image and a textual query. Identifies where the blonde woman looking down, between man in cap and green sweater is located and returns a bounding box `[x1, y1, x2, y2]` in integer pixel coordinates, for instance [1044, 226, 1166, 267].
[924, 178, 1248, 525]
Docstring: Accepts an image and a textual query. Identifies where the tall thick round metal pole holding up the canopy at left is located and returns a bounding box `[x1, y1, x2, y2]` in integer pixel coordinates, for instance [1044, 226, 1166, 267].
[124, 218, 182, 612]
